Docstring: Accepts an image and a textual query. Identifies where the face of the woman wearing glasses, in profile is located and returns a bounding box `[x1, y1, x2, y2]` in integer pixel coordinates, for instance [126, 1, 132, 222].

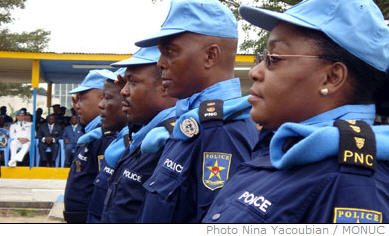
[249, 23, 327, 129]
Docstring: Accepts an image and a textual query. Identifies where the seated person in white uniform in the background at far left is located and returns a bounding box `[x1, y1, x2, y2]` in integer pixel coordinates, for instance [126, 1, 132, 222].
[8, 110, 31, 167]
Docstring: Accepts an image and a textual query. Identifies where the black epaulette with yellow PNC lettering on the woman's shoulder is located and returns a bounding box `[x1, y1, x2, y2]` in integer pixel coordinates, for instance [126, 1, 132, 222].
[334, 120, 376, 171]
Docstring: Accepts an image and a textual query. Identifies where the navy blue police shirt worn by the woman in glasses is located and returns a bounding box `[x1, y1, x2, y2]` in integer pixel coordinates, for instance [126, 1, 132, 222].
[203, 106, 389, 223]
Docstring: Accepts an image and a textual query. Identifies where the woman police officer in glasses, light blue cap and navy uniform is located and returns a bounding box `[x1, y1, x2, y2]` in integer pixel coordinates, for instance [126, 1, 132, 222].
[203, 0, 389, 223]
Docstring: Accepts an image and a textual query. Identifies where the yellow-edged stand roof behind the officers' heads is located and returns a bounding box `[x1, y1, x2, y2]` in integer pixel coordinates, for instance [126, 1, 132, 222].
[0, 51, 254, 87]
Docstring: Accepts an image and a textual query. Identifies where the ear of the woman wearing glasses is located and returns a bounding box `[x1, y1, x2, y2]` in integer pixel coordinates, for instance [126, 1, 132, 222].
[321, 62, 350, 95]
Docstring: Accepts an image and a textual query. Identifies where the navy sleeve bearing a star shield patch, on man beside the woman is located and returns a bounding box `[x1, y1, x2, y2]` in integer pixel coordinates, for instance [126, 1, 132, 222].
[196, 120, 257, 219]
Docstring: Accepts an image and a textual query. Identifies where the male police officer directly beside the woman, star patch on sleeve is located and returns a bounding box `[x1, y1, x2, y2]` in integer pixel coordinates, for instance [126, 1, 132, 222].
[136, 0, 257, 222]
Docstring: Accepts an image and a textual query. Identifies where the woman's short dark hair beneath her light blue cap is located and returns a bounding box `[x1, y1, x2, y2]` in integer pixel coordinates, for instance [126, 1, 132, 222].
[295, 26, 389, 104]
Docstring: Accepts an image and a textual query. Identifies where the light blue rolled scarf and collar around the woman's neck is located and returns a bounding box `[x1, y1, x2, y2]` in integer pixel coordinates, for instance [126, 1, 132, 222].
[270, 105, 378, 169]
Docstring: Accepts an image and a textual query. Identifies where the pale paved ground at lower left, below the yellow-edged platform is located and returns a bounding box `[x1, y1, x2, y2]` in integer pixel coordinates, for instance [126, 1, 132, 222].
[0, 179, 66, 223]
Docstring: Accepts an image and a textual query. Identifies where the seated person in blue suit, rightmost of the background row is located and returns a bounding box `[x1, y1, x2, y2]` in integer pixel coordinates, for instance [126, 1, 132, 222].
[62, 115, 84, 166]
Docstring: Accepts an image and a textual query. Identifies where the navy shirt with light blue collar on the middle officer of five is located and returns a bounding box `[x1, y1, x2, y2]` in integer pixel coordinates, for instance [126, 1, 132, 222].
[102, 107, 175, 223]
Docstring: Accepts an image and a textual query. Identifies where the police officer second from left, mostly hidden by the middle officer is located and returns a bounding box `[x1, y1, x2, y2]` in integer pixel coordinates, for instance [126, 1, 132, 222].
[87, 70, 128, 223]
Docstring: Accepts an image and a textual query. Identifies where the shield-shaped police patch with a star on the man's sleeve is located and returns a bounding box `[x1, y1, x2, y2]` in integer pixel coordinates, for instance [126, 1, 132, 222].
[202, 152, 232, 191]
